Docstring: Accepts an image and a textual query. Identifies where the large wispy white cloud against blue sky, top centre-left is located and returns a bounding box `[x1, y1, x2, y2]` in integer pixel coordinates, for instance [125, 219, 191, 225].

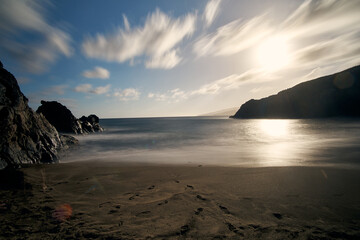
[82, 10, 196, 68]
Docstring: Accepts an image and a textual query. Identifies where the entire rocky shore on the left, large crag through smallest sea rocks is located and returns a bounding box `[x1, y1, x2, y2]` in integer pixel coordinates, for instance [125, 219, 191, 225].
[0, 62, 103, 169]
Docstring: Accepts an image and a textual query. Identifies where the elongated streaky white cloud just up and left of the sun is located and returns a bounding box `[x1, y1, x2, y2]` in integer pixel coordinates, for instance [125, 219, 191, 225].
[193, 15, 273, 56]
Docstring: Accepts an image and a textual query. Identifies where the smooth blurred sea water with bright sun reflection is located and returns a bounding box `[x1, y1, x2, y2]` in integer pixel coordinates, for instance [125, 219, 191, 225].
[62, 117, 360, 168]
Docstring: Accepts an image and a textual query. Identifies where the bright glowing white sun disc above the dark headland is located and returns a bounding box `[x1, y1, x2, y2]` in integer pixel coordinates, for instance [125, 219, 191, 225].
[257, 36, 291, 71]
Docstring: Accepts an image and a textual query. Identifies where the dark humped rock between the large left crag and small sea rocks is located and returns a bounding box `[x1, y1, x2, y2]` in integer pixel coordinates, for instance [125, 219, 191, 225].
[36, 101, 84, 134]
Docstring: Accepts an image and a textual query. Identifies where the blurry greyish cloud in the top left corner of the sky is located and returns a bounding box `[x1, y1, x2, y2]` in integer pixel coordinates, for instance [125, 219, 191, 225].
[0, 0, 73, 73]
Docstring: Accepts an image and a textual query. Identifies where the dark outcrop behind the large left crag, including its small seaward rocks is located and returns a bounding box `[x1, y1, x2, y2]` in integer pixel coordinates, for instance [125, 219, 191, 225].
[36, 101, 103, 134]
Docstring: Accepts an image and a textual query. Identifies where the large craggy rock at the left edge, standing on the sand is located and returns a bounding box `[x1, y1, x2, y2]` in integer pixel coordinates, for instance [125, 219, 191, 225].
[0, 61, 63, 168]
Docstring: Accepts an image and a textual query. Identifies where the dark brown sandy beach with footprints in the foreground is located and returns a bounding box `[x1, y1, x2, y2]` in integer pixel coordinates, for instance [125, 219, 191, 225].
[0, 162, 360, 239]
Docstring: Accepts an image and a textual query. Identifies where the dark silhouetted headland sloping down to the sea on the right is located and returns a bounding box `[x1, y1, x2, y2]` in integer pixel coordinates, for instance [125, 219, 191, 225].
[232, 66, 360, 118]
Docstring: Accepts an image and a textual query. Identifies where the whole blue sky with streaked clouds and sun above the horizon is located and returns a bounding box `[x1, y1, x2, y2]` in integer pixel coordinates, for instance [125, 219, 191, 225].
[0, 0, 360, 118]
